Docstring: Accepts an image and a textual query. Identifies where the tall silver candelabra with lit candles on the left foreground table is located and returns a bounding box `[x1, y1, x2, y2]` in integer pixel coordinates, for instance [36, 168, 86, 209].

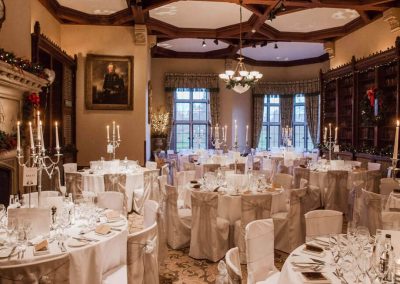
[17, 111, 62, 207]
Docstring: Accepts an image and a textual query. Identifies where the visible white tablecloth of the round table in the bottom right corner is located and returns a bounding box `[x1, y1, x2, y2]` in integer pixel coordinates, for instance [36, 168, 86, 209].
[278, 230, 400, 284]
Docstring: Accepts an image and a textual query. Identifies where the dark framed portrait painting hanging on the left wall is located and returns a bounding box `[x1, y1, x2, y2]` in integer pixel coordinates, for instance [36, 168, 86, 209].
[85, 54, 133, 110]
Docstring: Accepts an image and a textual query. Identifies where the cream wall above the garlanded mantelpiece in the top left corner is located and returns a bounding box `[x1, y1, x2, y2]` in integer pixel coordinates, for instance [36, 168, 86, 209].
[0, 0, 31, 59]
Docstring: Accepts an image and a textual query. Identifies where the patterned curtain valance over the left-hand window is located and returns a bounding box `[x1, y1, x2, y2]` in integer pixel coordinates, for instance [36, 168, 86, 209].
[164, 73, 219, 92]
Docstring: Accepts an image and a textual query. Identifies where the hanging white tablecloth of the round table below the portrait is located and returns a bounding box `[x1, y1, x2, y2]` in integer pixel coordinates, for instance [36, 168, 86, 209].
[81, 171, 144, 212]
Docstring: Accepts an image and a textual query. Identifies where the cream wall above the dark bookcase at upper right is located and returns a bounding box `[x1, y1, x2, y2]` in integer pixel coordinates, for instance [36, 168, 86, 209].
[330, 18, 400, 68]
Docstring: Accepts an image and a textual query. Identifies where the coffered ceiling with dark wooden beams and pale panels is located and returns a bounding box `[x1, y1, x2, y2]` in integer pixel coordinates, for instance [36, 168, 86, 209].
[39, 0, 400, 65]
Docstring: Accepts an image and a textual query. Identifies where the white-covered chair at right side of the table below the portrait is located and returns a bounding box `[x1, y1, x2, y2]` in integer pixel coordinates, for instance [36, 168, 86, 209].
[133, 170, 160, 215]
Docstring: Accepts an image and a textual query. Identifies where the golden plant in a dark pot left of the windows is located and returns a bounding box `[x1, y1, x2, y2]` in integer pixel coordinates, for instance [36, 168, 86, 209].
[151, 110, 169, 152]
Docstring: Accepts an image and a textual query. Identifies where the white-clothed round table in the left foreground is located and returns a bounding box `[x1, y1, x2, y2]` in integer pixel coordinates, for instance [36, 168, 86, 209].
[0, 218, 128, 284]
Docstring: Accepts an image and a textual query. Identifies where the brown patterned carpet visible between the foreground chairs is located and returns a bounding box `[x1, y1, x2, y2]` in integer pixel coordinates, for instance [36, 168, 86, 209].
[129, 214, 288, 284]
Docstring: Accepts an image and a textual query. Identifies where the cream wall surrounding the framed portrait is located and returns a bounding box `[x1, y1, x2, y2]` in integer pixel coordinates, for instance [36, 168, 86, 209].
[61, 25, 150, 165]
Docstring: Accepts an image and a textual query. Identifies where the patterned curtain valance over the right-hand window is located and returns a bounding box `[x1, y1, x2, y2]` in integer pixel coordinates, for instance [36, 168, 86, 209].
[253, 79, 320, 96]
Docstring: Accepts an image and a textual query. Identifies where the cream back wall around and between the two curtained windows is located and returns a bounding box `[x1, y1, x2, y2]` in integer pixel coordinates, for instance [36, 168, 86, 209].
[151, 58, 329, 149]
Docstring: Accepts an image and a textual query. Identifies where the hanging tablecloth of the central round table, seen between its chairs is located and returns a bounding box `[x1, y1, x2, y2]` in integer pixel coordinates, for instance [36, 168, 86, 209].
[184, 184, 287, 225]
